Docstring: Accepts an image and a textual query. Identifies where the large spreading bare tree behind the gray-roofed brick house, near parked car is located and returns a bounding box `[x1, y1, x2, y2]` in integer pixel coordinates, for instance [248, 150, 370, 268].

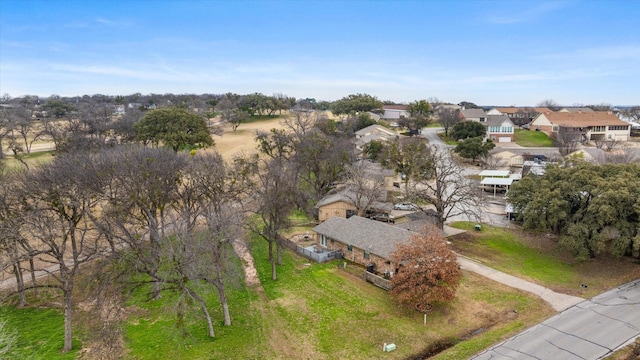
[409, 146, 482, 229]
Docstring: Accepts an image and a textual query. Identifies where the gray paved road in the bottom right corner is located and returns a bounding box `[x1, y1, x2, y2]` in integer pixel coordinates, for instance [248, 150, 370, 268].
[471, 280, 640, 360]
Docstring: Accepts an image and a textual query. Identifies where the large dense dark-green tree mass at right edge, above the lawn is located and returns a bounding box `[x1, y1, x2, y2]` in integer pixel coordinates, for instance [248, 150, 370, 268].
[507, 162, 640, 259]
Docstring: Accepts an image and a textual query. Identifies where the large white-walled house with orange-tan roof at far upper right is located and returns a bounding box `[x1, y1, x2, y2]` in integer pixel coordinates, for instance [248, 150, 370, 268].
[531, 111, 631, 142]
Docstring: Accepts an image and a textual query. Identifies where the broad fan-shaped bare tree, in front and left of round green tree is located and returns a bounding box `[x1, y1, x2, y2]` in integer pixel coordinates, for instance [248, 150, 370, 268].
[93, 146, 185, 298]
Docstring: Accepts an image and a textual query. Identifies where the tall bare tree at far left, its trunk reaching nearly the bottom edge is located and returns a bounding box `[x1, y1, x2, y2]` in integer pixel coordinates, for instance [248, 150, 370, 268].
[21, 155, 108, 352]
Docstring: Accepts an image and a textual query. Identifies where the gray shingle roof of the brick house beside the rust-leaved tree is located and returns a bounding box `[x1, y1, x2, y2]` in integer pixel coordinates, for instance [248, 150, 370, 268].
[313, 216, 417, 259]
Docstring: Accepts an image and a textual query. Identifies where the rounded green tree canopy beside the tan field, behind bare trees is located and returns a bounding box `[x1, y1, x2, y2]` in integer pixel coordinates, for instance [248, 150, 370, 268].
[134, 107, 214, 152]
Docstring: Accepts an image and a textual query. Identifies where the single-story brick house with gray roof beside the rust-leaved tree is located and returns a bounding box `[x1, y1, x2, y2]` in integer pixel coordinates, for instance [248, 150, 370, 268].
[313, 216, 418, 276]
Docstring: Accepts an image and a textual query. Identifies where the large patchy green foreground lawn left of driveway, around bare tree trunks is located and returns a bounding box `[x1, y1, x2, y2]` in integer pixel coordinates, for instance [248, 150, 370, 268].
[2, 229, 553, 359]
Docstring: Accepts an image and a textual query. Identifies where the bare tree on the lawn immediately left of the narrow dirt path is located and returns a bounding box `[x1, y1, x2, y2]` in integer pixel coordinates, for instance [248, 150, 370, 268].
[176, 153, 250, 328]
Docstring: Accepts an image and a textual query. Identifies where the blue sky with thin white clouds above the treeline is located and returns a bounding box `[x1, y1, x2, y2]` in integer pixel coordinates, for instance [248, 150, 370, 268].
[0, 0, 640, 106]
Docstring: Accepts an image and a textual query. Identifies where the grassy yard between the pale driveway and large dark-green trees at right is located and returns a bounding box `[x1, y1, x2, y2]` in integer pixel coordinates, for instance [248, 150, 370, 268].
[452, 222, 640, 298]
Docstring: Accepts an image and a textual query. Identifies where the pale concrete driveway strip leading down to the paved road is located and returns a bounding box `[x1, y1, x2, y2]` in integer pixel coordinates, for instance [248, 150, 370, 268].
[458, 255, 585, 311]
